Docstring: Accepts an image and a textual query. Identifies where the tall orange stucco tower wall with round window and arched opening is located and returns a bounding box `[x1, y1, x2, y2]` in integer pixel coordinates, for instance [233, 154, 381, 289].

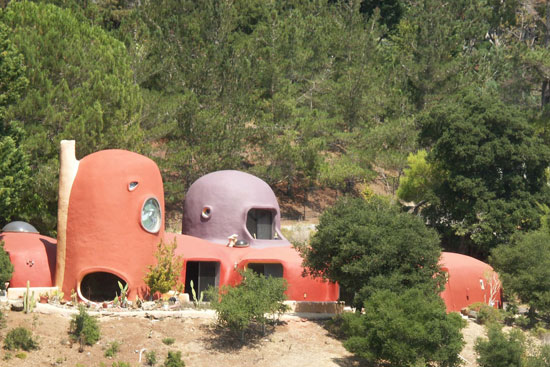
[62, 150, 164, 299]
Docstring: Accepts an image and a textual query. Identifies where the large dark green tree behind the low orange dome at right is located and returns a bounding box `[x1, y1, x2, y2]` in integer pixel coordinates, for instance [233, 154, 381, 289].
[419, 89, 550, 257]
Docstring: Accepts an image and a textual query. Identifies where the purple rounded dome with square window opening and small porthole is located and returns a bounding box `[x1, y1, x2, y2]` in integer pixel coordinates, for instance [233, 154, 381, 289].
[182, 170, 290, 248]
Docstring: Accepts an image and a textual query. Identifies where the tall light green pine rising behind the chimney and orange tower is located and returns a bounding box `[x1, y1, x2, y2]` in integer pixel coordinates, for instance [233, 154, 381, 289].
[0, 1, 143, 234]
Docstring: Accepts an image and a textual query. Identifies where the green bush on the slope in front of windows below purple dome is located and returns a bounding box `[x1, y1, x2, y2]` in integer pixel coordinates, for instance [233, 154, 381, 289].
[206, 269, 287, 341]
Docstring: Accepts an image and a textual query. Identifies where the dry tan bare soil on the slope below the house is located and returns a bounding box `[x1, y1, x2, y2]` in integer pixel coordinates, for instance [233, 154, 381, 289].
[0, 309, 492, 367]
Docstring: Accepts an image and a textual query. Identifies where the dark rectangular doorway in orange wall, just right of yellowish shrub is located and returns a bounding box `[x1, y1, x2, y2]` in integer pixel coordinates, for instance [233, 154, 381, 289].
[185, 261, 220, 301]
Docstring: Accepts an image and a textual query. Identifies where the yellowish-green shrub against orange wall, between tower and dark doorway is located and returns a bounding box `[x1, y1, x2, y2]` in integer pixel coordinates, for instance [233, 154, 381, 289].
[144, 239, 183, 297]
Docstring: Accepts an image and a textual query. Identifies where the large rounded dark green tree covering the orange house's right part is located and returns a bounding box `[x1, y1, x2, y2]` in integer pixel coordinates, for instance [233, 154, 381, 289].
[302, 197, 441, 307]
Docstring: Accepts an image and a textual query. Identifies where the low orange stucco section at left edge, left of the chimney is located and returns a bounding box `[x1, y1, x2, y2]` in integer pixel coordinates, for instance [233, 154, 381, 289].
[0, 232, 56, 288]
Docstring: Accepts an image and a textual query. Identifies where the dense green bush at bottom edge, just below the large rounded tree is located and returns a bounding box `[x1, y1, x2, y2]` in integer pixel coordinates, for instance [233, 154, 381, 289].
[344, 288, 465, 367]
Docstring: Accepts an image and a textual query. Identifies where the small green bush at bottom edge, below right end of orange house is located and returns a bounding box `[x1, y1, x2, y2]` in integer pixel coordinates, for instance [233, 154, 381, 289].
[475, 324, 525, 367]
